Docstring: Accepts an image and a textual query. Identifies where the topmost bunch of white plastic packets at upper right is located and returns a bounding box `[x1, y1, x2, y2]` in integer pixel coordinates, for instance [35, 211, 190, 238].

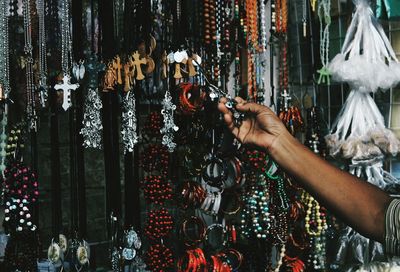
[328, 0, 400, 93]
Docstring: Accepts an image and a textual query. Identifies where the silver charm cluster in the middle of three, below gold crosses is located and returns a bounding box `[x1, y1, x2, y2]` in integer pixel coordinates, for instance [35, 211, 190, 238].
[121, 90, 139, 153]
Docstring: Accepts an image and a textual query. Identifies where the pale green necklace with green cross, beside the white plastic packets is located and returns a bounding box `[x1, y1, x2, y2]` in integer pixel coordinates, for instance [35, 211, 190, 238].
[318, 0, 331, 85]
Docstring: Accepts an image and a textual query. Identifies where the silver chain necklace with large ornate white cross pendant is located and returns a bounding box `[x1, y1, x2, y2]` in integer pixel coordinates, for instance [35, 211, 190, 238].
[54, 0, 79, 111]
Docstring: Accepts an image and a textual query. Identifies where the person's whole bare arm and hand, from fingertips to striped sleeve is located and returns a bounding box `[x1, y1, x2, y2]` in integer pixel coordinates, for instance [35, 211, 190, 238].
[218, 98, 391, 242]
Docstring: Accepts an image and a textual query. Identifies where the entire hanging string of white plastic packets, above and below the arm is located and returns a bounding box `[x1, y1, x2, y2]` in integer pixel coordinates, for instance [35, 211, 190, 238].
[325, 0, 400, 271]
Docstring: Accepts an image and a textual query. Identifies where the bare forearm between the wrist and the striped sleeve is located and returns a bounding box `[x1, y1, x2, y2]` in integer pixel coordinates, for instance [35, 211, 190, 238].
[269, 135, 390, 241]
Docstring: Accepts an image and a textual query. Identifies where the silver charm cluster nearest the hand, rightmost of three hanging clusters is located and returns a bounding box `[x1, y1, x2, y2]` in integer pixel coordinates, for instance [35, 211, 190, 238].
[160, 90, 179, 152]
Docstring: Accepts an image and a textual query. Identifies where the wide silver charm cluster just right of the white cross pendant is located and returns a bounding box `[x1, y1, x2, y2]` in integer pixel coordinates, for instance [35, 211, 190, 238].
[80, 88, 103, 149]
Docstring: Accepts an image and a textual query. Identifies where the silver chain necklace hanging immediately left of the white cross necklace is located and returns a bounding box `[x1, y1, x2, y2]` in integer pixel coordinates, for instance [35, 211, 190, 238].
[36, 0, 48, 107]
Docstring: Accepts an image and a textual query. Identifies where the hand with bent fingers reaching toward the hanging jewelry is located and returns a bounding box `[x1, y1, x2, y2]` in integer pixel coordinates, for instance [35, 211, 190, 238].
[218, 97, 290, 151]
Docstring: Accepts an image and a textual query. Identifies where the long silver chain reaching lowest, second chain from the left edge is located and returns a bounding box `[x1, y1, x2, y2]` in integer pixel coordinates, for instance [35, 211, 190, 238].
[23, 0, 37, 131]
